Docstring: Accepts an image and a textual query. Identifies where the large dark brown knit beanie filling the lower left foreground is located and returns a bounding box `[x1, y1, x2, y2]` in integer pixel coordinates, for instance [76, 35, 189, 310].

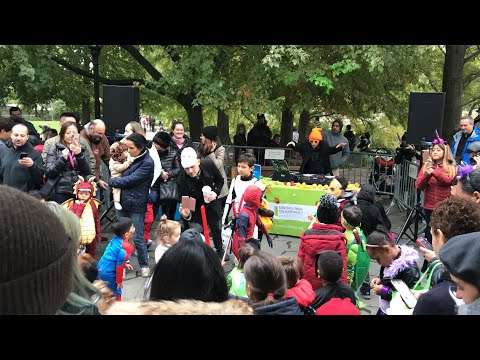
[0, 185, 75, 315]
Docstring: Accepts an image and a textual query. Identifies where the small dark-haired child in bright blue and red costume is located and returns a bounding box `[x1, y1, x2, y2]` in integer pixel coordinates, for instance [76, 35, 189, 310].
[98, 217, 135, 301]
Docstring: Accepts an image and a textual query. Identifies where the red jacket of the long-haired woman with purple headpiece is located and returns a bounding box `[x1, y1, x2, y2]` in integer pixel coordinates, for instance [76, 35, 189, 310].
[415, 164, 455, 210]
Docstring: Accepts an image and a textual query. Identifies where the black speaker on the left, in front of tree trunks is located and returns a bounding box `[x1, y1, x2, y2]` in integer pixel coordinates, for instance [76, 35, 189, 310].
[103, 85, 140, 136]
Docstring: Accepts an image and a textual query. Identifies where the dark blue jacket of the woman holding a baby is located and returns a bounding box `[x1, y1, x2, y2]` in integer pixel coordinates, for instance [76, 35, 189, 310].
[108, 149, 154, 212]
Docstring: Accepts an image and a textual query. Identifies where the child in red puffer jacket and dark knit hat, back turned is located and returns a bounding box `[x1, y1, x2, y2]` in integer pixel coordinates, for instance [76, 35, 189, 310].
[298, 194, 348, 290]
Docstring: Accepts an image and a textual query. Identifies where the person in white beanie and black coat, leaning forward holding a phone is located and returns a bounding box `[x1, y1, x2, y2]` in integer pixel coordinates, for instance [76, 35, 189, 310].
[177, 147, 229, 260]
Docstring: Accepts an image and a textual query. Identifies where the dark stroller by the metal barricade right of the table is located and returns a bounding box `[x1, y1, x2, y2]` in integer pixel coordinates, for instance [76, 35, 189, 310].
[368, 148, 395, 193]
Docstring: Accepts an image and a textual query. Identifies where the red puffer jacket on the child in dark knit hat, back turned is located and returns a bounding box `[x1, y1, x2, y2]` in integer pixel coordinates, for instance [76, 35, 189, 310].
[298, 223, 348, 290]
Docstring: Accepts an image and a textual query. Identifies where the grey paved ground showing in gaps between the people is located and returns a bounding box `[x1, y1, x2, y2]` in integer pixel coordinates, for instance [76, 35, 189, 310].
[97, 191, 423, 315]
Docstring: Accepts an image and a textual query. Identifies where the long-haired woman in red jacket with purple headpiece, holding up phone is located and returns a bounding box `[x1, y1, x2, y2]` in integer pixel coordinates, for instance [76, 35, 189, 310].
[415, 131, 457, 243]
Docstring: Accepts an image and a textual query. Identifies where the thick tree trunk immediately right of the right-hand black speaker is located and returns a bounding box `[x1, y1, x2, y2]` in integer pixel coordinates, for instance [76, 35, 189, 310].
[441, 45, 467, 143]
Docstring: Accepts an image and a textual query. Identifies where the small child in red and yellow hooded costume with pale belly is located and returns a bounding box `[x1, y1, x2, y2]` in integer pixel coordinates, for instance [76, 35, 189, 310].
[62, 176, 102, 259]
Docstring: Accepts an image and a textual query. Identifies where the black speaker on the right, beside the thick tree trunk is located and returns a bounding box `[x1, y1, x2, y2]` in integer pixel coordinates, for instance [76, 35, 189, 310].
[407, 92, 445, 145]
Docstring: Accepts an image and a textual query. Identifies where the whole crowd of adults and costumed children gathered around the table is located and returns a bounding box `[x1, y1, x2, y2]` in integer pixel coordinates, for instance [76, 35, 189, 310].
[0, 109, 480, 315]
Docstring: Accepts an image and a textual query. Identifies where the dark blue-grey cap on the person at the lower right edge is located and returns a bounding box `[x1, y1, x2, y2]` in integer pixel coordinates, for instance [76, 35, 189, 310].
[438, 232, 480, 289]
